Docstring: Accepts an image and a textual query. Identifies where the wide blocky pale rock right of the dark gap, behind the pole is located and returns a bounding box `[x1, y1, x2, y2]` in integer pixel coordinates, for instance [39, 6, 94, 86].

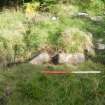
[59, 53, 85, 64]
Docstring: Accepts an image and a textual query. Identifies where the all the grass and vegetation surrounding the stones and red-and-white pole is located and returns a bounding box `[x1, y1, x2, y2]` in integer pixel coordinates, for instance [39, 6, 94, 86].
[0, 0, 105, 105]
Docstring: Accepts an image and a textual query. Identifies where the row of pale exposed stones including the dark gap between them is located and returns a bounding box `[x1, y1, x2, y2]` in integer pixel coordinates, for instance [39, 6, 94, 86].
[30, 52, 85, 65]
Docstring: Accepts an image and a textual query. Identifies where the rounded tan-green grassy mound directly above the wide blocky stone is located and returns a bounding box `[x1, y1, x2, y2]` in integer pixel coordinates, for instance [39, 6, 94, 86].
[48, 28, 93, 53]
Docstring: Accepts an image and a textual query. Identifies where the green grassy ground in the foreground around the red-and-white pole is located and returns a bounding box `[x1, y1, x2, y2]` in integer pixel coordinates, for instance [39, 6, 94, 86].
[0, 61, 105, 105]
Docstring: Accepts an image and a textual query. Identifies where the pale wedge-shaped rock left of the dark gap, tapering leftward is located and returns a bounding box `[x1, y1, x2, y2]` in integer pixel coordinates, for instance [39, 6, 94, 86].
[30, 52, 51, 64]
